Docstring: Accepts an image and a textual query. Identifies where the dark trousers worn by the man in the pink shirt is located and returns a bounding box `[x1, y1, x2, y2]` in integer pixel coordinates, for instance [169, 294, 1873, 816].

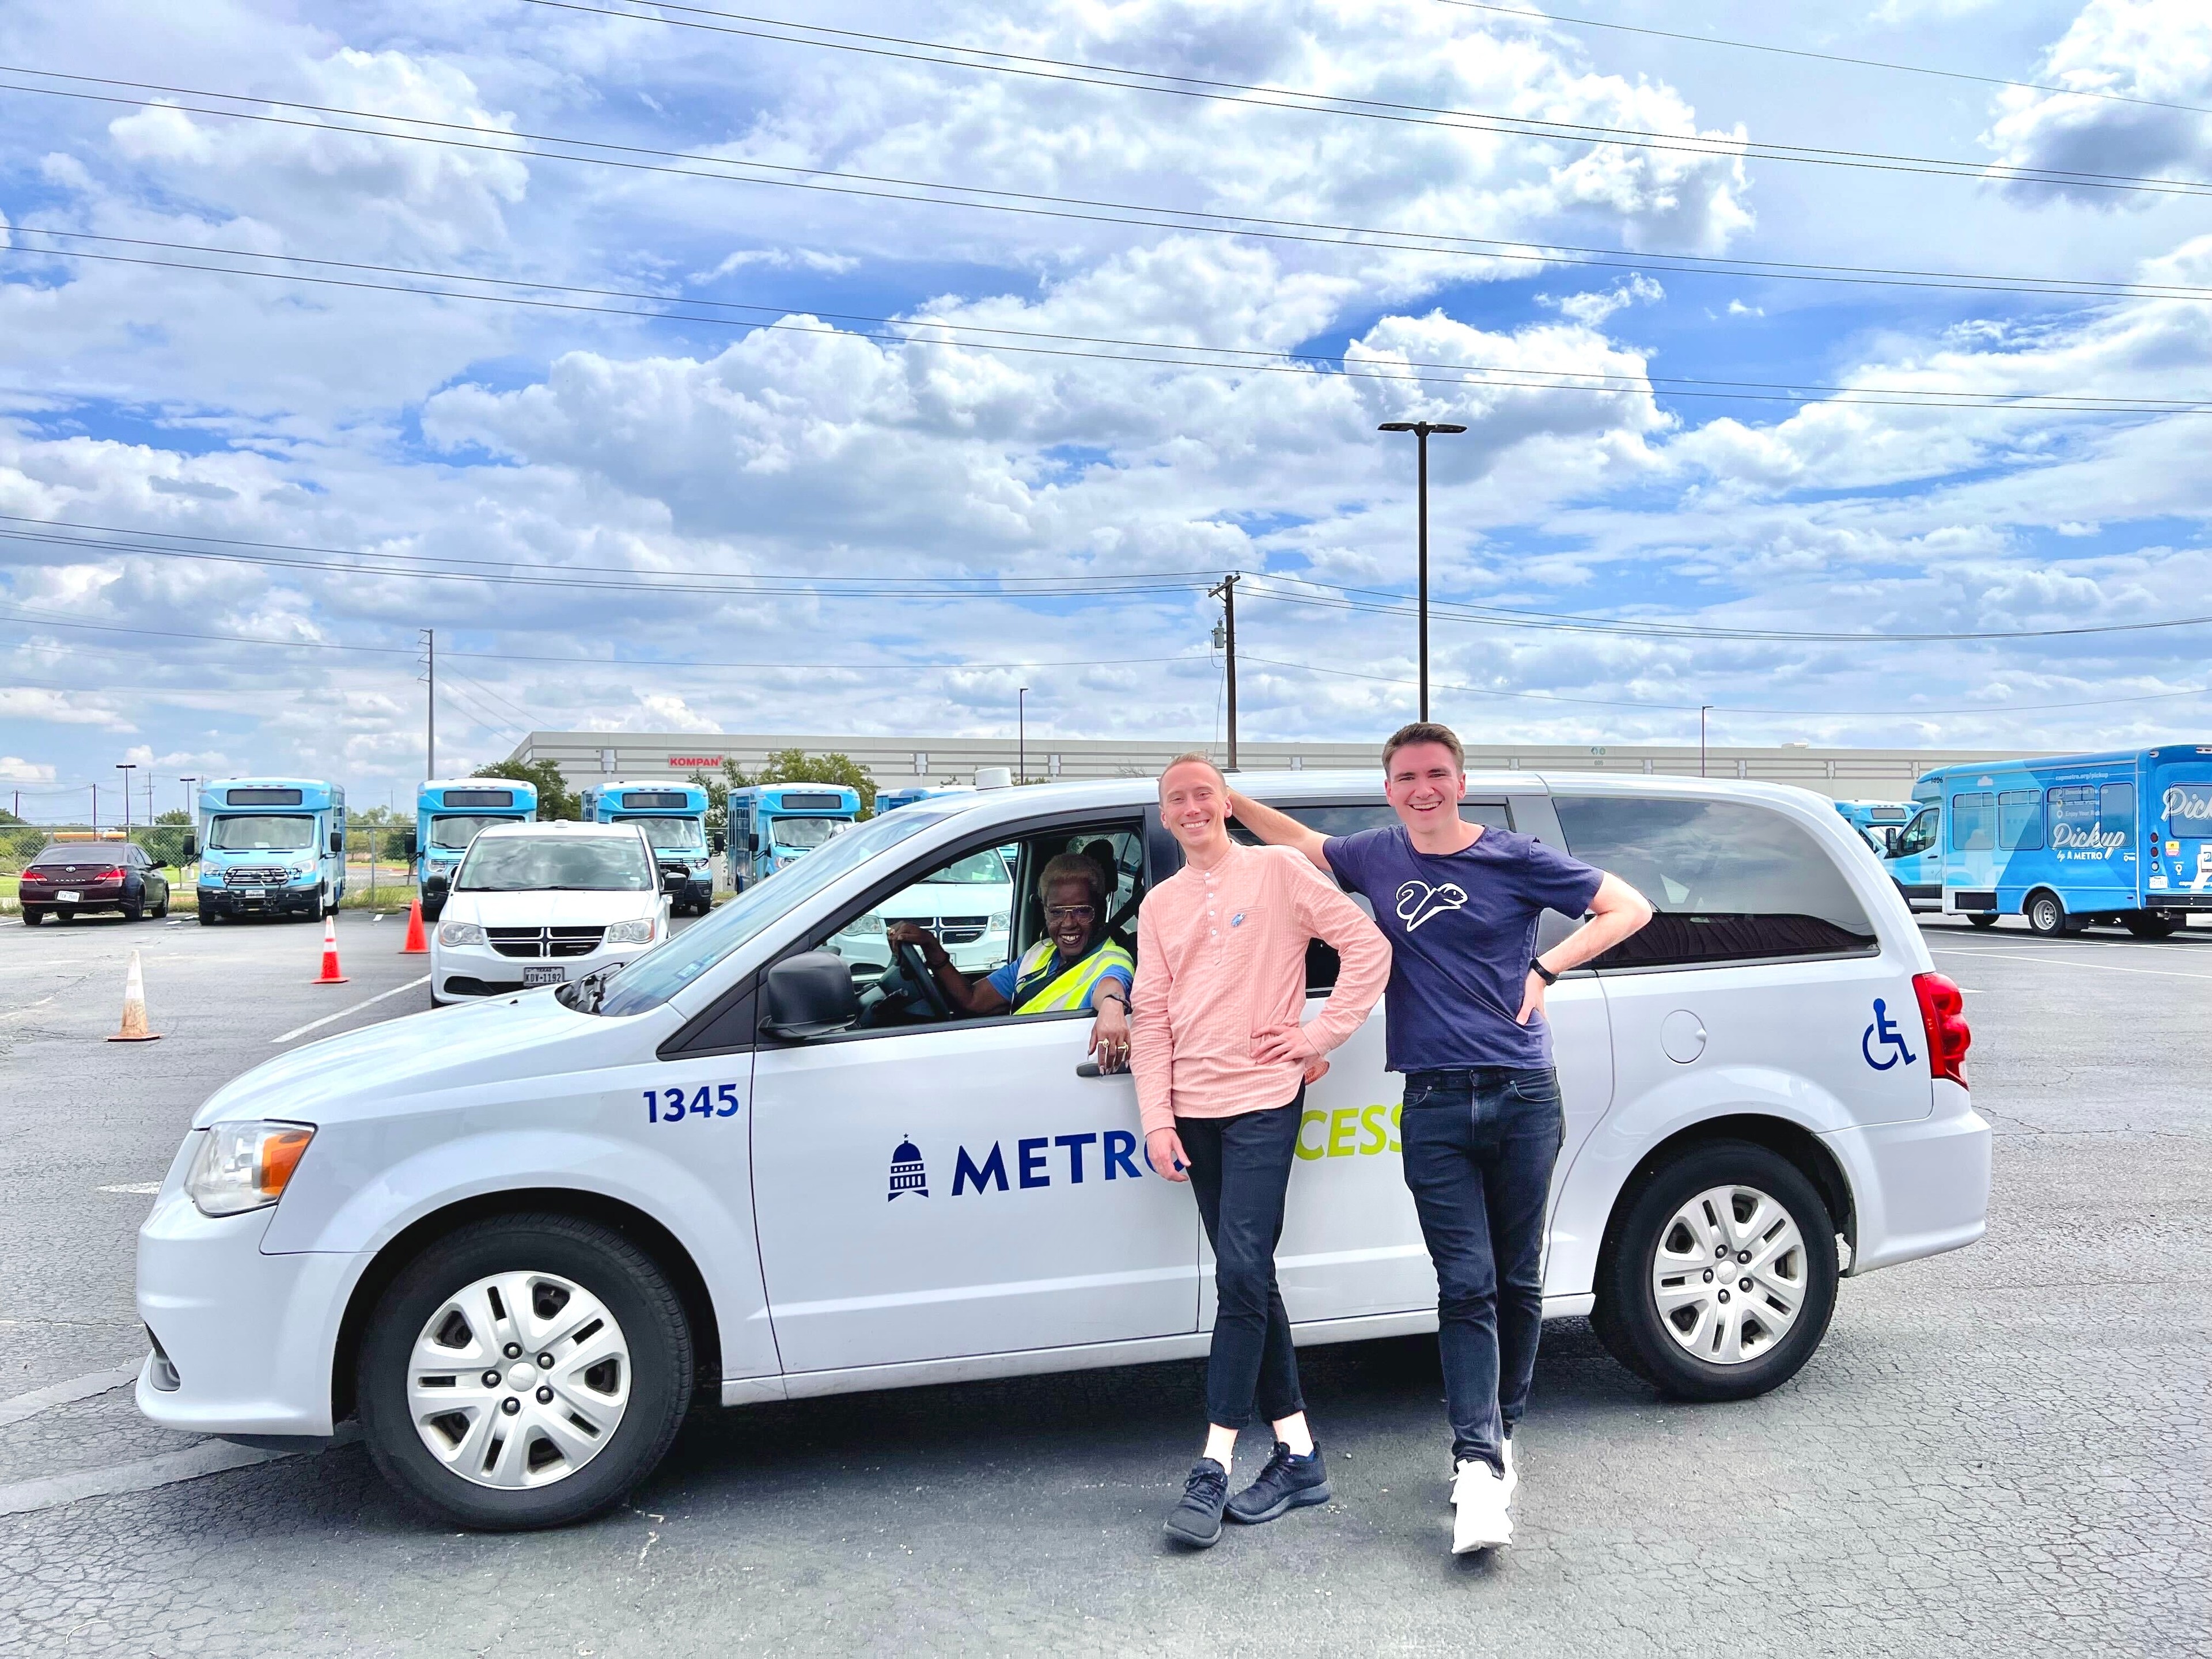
[1175, 1086, 1305, 1429]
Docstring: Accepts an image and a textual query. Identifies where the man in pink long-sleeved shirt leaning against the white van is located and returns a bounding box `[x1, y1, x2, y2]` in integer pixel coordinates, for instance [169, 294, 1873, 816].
[1130, 754, 1389, 1548]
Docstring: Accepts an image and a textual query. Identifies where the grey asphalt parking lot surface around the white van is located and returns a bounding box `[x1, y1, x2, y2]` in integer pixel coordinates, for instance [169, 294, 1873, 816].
[0, 914, 2212, 1659]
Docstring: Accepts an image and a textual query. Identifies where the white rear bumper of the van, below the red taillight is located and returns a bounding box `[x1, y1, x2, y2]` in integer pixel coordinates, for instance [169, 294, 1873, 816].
[1820, 1082, 1988, 1274]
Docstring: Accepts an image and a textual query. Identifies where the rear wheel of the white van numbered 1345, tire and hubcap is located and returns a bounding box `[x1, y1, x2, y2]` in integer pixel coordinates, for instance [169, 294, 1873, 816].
[1590, 1141, 1836, 1400]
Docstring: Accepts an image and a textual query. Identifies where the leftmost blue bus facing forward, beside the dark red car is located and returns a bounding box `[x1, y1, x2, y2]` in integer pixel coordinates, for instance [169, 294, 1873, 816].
[195, 779, 345, 927]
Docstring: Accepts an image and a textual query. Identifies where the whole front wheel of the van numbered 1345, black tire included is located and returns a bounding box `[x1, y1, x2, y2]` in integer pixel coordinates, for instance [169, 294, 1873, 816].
[356, 1214, 692, 1531]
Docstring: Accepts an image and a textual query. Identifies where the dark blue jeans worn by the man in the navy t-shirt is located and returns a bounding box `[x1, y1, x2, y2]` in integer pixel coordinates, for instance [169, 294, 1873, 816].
[1398, 1066, 1566, 1467]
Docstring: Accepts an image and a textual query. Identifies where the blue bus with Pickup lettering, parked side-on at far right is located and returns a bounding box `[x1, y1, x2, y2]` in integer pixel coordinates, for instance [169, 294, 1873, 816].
[1914, 743, 2212, 938]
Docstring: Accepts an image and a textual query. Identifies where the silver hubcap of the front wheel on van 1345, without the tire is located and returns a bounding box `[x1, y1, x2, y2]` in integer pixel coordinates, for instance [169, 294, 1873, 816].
[407, 1272, 630, 1491]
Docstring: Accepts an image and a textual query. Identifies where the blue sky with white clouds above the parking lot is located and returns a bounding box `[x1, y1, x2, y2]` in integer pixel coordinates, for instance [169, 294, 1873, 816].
[0, 0, 2212, 821]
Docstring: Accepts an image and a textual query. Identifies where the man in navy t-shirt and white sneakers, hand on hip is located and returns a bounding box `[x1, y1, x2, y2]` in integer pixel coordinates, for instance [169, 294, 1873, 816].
[1230, 721, 1652, 1555]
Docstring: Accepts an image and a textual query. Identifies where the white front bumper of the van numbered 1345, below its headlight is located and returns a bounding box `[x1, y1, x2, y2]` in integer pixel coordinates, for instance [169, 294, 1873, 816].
[137, 1188, 367, 1435]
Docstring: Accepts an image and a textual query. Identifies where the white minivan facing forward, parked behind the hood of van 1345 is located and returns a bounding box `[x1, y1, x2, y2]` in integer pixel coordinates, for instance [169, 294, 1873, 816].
[429, 823, 668, 1002]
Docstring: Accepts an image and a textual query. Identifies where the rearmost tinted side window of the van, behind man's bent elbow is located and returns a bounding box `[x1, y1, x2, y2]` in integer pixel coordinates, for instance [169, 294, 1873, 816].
[1553, 794, 1880, 969]
